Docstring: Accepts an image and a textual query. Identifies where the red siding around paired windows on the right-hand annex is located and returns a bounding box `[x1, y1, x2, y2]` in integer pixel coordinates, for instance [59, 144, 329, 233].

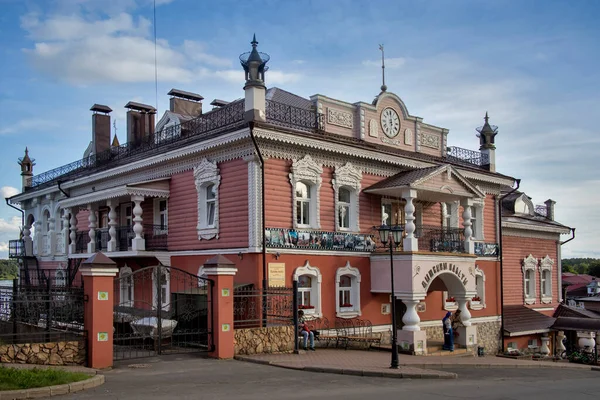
[502, 235, 560, 308]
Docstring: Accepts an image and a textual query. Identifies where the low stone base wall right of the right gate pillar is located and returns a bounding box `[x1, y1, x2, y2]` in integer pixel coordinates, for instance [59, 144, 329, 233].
[234, 326, 294, 355]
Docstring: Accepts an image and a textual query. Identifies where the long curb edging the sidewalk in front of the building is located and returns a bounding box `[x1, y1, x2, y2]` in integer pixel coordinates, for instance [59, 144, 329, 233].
[234, 356, 458, 378]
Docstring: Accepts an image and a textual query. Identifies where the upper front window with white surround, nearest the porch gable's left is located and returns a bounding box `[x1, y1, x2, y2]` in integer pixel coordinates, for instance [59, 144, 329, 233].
[331, 163, 362, 232]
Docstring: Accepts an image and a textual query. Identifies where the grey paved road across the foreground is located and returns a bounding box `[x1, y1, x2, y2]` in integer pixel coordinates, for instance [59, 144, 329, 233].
[53, 356, 600, 400]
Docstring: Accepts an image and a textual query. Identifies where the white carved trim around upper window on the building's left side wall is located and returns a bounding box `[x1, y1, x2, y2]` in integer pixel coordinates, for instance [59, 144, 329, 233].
[194, 158, 221, 240]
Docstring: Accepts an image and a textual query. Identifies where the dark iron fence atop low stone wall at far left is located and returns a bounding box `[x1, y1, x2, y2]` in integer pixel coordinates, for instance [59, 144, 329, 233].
[0, 279, 84, 344]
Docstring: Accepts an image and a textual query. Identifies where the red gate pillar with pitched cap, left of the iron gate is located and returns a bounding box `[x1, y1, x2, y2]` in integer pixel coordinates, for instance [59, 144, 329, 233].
[79, 253, 119, 368]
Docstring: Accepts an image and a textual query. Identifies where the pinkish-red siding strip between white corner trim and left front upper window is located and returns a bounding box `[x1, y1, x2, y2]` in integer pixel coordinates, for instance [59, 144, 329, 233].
[265, 158, 292, 229]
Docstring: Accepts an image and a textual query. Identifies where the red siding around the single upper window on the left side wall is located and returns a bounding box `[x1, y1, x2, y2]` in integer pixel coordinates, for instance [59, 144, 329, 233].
[168, 160, 248, 251]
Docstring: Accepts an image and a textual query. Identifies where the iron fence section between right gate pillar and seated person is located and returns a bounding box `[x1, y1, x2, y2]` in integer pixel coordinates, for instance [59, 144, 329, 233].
[233, 286, 294, 329]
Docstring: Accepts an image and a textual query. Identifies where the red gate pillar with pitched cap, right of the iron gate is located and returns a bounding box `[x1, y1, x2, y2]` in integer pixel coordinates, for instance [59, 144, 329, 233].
[204, 255, 237, 358]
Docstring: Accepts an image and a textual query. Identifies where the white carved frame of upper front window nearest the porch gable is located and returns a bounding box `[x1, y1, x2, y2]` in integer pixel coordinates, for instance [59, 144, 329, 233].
[332, 162, 362, 232]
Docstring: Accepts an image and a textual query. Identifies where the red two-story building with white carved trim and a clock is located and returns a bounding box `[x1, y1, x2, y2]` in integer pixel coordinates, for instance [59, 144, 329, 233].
[10, 36, 570, 354]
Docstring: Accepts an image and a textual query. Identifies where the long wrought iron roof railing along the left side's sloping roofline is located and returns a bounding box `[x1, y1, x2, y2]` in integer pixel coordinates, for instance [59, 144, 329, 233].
[29, 100, 244, 188]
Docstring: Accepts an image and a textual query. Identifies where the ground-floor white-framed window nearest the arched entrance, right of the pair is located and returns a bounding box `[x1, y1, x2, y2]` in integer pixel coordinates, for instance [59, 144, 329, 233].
[335, 262, 361, 318]
